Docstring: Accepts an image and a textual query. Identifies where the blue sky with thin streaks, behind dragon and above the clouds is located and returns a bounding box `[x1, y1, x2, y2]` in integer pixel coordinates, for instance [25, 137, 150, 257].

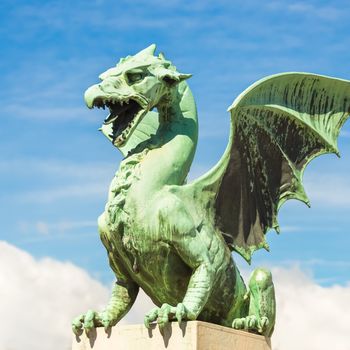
[0, 0, 350, 286]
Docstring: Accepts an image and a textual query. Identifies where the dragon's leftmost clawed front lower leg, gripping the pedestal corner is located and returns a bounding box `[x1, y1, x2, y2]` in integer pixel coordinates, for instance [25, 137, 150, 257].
[72, 281, 139, 335]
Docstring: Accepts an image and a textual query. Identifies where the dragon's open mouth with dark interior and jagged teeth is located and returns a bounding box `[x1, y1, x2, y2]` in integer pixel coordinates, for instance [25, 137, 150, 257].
[93, 97, 147, 146]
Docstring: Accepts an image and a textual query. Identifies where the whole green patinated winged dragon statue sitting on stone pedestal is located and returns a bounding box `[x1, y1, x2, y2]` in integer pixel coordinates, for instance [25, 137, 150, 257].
[72, 45, 350, 337]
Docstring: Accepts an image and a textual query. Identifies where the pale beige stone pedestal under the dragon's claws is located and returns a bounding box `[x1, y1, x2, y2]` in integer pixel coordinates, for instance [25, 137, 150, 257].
[72, 321, 271, 350]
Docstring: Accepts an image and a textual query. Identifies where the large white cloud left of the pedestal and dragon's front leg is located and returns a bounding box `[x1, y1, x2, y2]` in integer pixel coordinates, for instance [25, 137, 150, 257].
[0, 242, 109, 350]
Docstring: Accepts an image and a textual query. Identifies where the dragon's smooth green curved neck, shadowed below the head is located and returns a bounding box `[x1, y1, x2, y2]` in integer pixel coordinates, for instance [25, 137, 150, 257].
[131, 82, 198, 194]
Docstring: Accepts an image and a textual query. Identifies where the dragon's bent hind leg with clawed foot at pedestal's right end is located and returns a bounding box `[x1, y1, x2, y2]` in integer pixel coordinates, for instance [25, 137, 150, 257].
[232, 268, 276, 337]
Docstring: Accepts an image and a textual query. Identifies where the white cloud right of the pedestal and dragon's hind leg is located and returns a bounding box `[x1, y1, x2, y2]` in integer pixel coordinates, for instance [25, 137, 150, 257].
[272, 268, 350, 350]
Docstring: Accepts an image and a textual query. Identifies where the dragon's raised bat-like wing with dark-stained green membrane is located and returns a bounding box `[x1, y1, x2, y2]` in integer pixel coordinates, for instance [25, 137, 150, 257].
[187, 73, 350, 262]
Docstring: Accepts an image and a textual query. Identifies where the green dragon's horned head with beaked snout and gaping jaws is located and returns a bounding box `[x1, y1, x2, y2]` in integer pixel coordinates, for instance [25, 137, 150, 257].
[84, 44, 191, 147]
